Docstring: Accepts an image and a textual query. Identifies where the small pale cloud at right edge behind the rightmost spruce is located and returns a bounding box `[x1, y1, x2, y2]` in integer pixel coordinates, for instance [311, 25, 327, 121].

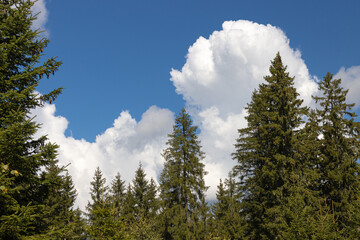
[334, 66, 360, 108]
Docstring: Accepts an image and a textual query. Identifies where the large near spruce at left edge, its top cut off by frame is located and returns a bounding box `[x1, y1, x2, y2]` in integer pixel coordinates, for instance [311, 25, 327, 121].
[0, 0, 75, 239]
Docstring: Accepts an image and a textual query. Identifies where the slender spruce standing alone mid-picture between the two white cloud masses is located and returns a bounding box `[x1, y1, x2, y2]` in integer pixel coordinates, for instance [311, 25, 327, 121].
[160, 108, 208, 239]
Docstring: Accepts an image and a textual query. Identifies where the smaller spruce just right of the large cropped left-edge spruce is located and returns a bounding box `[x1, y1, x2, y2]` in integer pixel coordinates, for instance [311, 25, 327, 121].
[32, 156, 85, 239]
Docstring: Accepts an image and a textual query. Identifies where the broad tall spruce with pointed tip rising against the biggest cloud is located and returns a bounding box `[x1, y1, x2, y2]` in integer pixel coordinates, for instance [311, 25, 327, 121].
[233, 53, 312, 239]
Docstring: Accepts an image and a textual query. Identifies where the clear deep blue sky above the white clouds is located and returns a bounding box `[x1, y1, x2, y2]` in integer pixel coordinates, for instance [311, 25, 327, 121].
[40, 0, 360, 141]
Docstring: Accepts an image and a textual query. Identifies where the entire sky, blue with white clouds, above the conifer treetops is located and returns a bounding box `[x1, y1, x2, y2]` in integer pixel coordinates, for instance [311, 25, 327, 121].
[34, 0, 360, 207]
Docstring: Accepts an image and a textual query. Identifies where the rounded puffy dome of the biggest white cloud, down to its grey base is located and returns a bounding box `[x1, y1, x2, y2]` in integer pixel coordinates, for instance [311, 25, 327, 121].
[171, 20, 316, 113]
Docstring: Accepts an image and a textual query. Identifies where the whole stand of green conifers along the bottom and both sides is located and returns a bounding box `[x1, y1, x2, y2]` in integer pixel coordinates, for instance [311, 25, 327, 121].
[0, 0, 360, 240]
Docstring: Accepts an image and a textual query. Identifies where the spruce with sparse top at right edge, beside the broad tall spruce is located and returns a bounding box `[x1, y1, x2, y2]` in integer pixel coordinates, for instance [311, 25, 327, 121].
[312, 73, 360, 239]
